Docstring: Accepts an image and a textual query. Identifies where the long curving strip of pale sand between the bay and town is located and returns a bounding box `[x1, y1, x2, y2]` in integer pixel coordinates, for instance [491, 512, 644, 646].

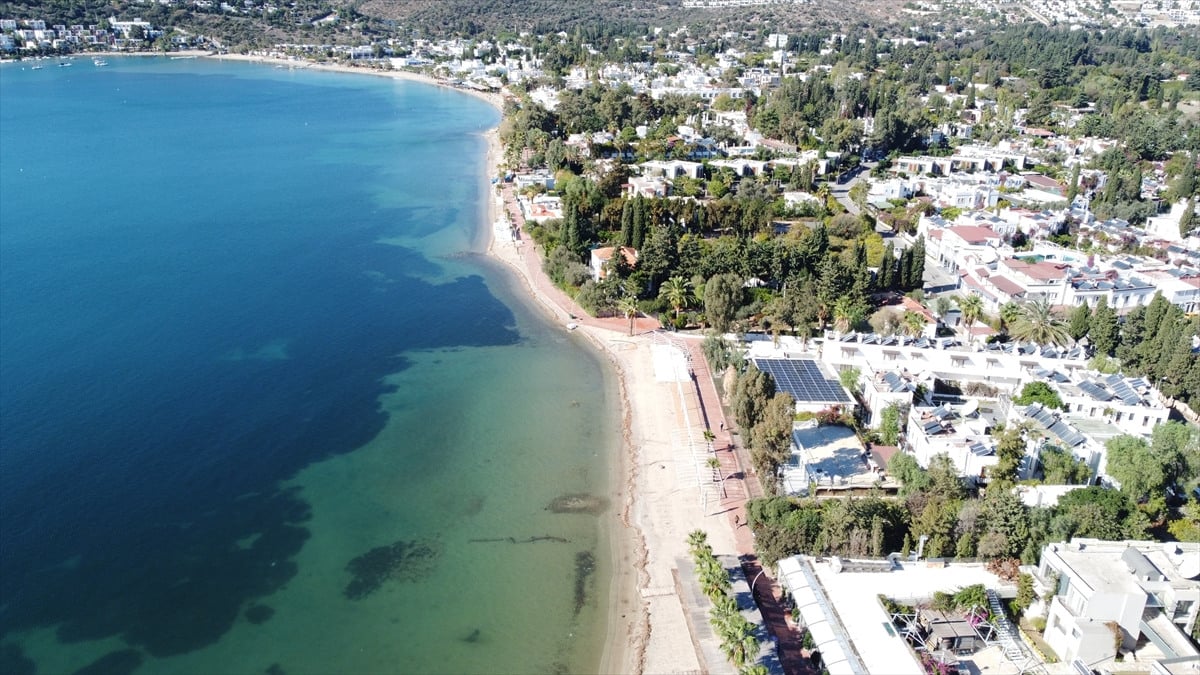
[193, 54, 740, 673]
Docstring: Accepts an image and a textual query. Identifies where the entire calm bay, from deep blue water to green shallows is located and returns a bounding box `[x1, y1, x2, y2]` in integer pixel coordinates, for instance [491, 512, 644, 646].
[0, 56, 620, 675]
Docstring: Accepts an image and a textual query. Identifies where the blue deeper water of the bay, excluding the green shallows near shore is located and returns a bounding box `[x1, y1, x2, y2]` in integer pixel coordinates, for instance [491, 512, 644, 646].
[0, 59, 614, 673]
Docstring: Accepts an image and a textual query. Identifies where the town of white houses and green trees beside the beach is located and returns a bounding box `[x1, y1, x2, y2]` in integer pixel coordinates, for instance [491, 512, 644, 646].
[0, 0, 1200, 675]
